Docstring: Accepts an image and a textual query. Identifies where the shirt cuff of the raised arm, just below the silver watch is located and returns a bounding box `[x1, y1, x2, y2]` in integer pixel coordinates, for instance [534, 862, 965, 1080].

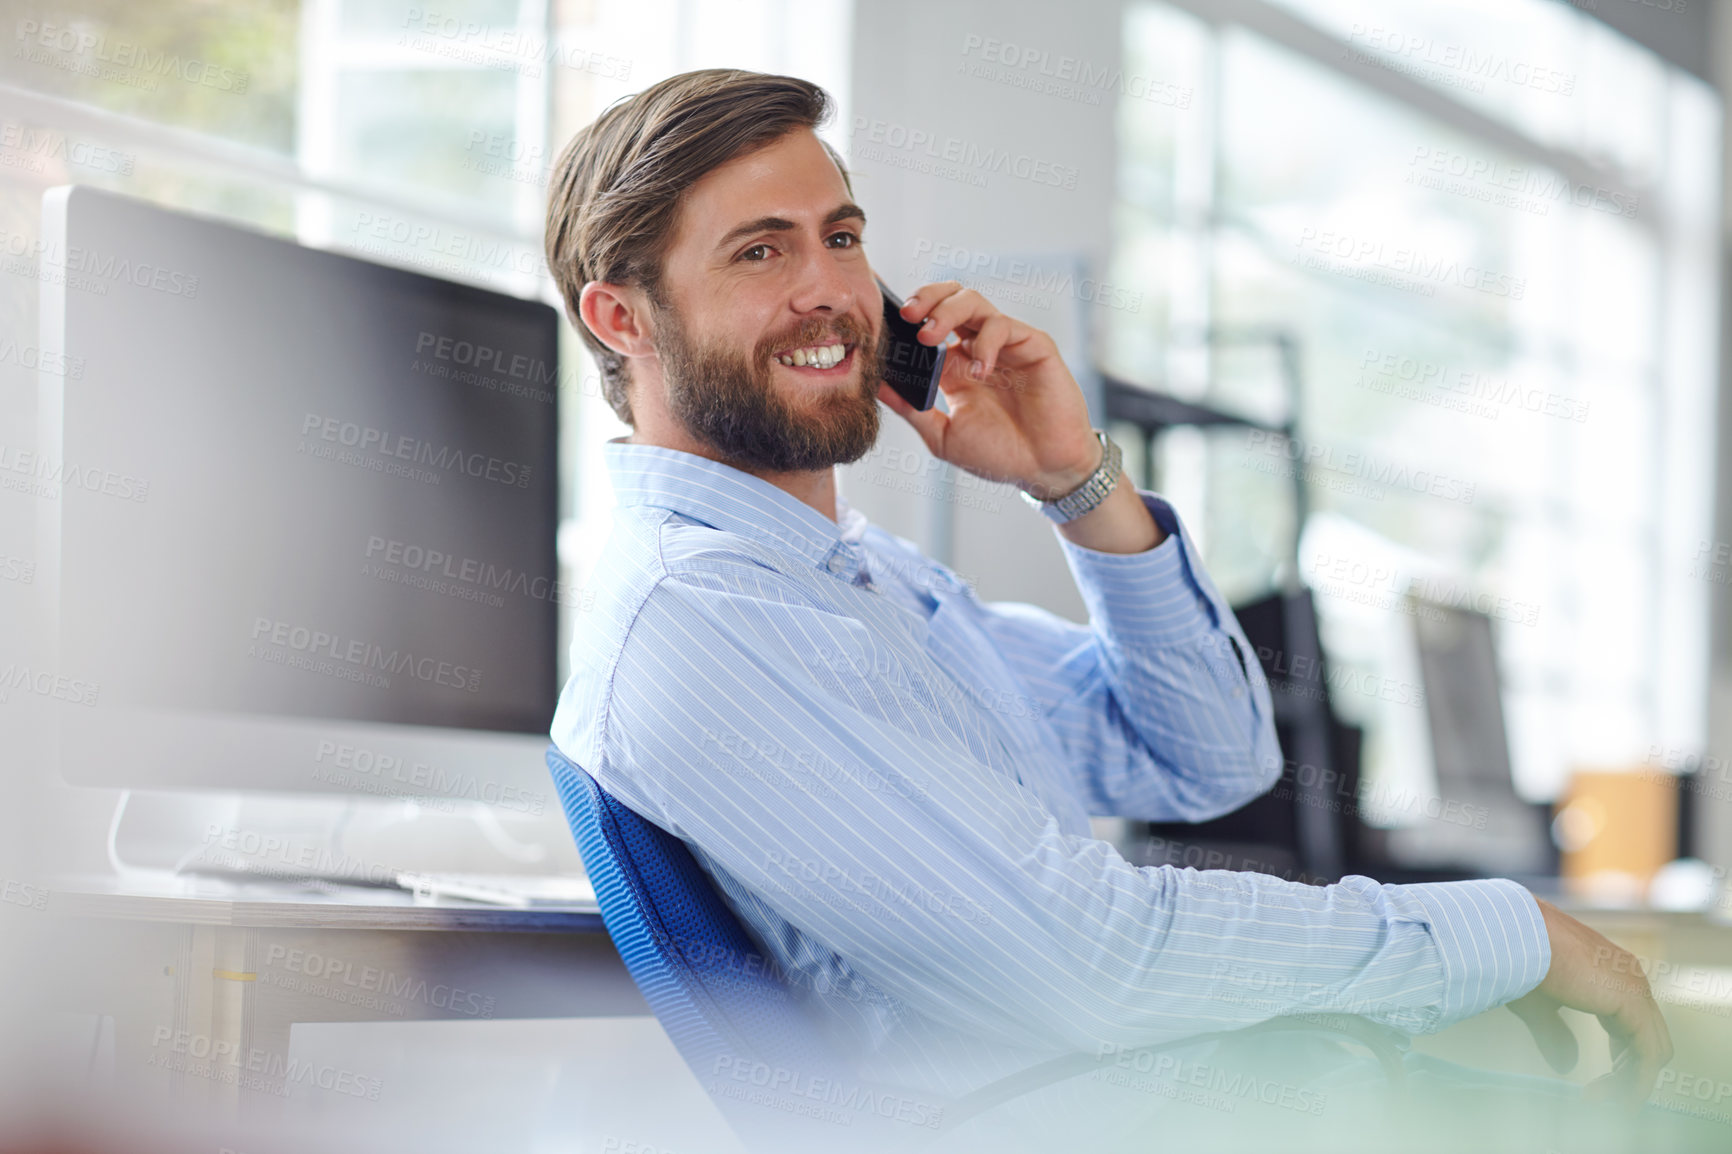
[1053, 489, 1219, 648]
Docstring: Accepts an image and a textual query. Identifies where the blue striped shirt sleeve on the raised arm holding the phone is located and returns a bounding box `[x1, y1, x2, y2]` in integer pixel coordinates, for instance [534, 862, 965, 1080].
[982, 490, 1282, 821]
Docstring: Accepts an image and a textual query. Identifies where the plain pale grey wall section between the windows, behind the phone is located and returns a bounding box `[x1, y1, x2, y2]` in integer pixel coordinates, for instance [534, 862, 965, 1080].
[840, 0, 1121, 622]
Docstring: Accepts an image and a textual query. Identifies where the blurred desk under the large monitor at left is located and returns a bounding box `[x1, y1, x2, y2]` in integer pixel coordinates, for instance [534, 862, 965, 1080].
[43, 880, 650, 1121]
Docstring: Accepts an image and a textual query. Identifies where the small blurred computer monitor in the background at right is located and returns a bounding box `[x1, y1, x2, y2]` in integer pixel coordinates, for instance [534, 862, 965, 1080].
[1389, 598, 1557, 877]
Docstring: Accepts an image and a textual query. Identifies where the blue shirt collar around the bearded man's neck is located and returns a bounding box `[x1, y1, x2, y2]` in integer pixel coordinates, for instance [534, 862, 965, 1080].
[603, 440, 868, 584]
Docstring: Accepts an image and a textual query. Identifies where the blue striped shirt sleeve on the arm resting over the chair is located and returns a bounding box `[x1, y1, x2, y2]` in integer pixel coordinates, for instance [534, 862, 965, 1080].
[591, 561, 1547, 1050]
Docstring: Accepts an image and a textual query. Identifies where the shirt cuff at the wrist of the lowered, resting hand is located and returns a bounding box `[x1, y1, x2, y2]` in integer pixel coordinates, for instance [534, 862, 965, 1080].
[1357, 878, 1552, 1029]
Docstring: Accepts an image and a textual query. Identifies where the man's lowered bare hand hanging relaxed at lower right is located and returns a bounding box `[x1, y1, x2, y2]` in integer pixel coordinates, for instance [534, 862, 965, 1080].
[1509, 899, 1671, 1107]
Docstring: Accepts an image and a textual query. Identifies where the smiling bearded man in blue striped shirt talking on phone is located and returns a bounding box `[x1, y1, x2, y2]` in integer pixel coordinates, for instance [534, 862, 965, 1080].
[547, 69, 1670, 1140]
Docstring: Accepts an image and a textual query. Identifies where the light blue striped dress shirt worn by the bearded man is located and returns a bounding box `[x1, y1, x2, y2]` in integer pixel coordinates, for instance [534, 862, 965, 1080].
[553, 440, 1550, 1115]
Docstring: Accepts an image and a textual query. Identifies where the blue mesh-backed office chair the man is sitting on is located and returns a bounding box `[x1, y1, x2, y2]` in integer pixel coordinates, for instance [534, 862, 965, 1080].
[547, 747, 1403, 1151]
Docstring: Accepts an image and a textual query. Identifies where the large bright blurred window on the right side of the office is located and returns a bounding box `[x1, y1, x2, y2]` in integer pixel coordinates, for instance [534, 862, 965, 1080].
[1103, 0, 1720, 820]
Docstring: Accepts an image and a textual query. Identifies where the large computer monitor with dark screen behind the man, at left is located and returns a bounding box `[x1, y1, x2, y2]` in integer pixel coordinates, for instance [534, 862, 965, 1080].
[40, 187, 561, 811]
